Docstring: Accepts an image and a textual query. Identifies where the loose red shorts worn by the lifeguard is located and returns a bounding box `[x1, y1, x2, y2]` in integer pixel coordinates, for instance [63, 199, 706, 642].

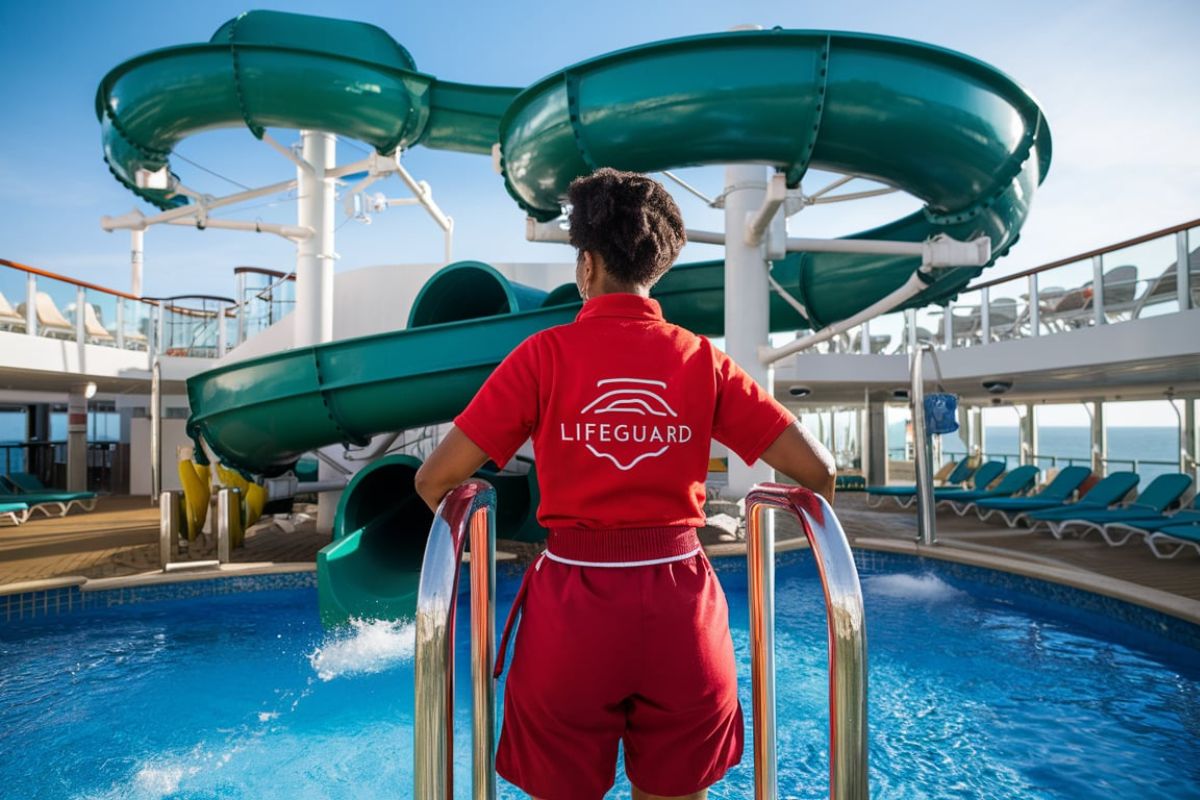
[496, 531, 743, 800]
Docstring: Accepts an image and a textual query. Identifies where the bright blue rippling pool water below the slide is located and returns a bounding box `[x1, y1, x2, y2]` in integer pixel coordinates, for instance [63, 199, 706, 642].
[0, 553, 1200, 800]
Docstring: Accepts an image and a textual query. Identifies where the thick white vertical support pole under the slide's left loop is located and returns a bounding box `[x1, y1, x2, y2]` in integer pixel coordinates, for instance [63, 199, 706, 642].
[293, 131, 341, 533]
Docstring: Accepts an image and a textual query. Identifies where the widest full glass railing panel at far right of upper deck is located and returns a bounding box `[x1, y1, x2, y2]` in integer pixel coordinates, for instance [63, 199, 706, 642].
[1103, 234, 1180, 323]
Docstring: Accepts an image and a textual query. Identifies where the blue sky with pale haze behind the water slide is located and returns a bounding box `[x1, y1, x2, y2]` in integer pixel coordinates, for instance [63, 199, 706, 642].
[0, 0, 1200, 295]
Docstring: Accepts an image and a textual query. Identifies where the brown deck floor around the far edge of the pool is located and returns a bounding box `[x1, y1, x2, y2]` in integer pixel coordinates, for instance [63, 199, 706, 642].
[0, 493, 1200, 624]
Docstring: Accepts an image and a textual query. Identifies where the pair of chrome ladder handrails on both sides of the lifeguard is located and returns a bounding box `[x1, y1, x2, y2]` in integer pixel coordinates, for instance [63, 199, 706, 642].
[413, 479, 869, 800]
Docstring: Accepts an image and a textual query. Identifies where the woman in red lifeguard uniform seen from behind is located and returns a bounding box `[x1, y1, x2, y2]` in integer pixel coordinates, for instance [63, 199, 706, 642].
[416, 169, 834, 800]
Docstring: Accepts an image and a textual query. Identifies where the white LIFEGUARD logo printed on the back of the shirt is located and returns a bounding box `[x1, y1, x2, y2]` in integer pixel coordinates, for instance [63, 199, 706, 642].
[559, 378, 691, 470]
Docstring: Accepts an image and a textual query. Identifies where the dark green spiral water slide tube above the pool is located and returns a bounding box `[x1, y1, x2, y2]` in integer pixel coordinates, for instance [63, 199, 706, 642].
[96, 11, 1050, 615]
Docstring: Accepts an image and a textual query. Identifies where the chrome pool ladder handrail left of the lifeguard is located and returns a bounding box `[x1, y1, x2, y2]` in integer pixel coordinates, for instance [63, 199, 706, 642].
[413, 480, 496, 800]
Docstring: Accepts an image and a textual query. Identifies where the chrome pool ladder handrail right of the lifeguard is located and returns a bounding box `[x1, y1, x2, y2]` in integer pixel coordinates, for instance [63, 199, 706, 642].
[746, 483, 870, 800]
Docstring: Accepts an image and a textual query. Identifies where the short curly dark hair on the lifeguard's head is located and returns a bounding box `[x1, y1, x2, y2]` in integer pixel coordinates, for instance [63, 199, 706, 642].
[566, 167, 688, 285]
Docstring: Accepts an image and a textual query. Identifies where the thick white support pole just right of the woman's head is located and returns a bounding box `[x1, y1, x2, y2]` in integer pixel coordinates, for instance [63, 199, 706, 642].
[725, 164, 774, 498]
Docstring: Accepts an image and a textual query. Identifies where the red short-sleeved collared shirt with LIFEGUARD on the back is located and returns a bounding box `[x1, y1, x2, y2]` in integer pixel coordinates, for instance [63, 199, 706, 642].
[454, 294, 796, 529]
